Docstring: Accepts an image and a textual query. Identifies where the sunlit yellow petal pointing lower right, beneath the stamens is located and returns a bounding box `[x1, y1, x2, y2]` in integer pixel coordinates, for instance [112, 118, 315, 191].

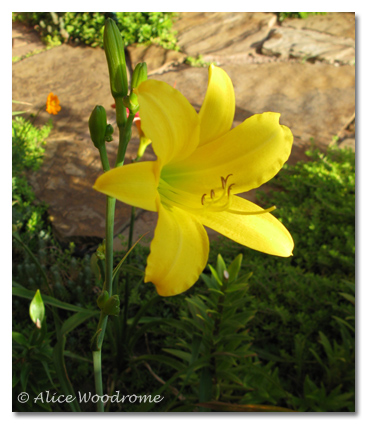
[198, 196, 294, 257]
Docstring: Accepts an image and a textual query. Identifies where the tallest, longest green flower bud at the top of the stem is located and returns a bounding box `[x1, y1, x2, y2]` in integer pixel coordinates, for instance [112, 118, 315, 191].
[104, 18, 128, 98]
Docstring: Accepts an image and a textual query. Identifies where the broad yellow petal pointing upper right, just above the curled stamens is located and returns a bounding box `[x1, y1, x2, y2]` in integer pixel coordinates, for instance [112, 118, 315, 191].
[163, 112, 293, 197]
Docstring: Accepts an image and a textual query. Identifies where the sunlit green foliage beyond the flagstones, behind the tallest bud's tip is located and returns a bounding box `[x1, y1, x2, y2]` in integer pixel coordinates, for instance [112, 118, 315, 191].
[13, 12, 180, 49]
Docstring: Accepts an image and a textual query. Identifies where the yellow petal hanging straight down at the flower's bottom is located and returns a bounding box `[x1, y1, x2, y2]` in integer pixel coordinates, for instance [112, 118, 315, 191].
[145, 205, 209, 297]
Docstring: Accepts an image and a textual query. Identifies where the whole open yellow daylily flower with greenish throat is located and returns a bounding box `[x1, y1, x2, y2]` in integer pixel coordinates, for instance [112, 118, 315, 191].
[94, 65, 294, 296]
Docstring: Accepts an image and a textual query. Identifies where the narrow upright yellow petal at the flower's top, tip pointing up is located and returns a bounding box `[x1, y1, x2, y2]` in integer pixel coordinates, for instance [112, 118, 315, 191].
[199, 65, 235, 145]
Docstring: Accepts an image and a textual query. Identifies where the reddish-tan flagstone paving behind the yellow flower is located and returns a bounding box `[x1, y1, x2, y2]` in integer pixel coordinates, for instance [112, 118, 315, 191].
[12, 12, 355, 249]
